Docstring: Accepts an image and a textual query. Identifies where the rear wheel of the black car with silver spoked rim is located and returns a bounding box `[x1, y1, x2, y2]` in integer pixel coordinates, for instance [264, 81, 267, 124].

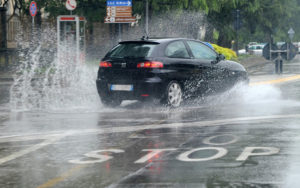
[164, 81, 183, 107]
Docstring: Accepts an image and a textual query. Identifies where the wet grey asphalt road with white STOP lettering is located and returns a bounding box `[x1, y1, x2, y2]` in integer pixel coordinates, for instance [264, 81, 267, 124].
[0, 58, 300, 188]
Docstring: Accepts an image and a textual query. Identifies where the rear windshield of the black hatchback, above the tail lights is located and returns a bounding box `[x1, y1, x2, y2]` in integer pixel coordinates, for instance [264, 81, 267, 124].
[107, 42, 157, 58]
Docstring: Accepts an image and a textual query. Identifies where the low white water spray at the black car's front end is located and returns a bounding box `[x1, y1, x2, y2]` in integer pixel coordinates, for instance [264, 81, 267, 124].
[192, 81, 300, 116]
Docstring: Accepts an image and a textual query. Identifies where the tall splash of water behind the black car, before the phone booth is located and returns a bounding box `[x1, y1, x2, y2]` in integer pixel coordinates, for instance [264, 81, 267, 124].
[10, 28, 101, 111]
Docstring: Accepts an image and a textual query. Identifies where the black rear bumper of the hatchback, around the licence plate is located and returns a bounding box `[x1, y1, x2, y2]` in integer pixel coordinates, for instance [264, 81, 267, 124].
[96, 78, 165, 100]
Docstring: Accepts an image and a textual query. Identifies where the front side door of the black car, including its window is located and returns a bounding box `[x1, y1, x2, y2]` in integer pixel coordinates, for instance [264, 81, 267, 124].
[186, 40, 224, 95]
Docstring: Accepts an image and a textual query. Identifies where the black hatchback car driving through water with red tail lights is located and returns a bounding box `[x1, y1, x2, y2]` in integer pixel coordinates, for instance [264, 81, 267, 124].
[96, 38, 248, 107]
